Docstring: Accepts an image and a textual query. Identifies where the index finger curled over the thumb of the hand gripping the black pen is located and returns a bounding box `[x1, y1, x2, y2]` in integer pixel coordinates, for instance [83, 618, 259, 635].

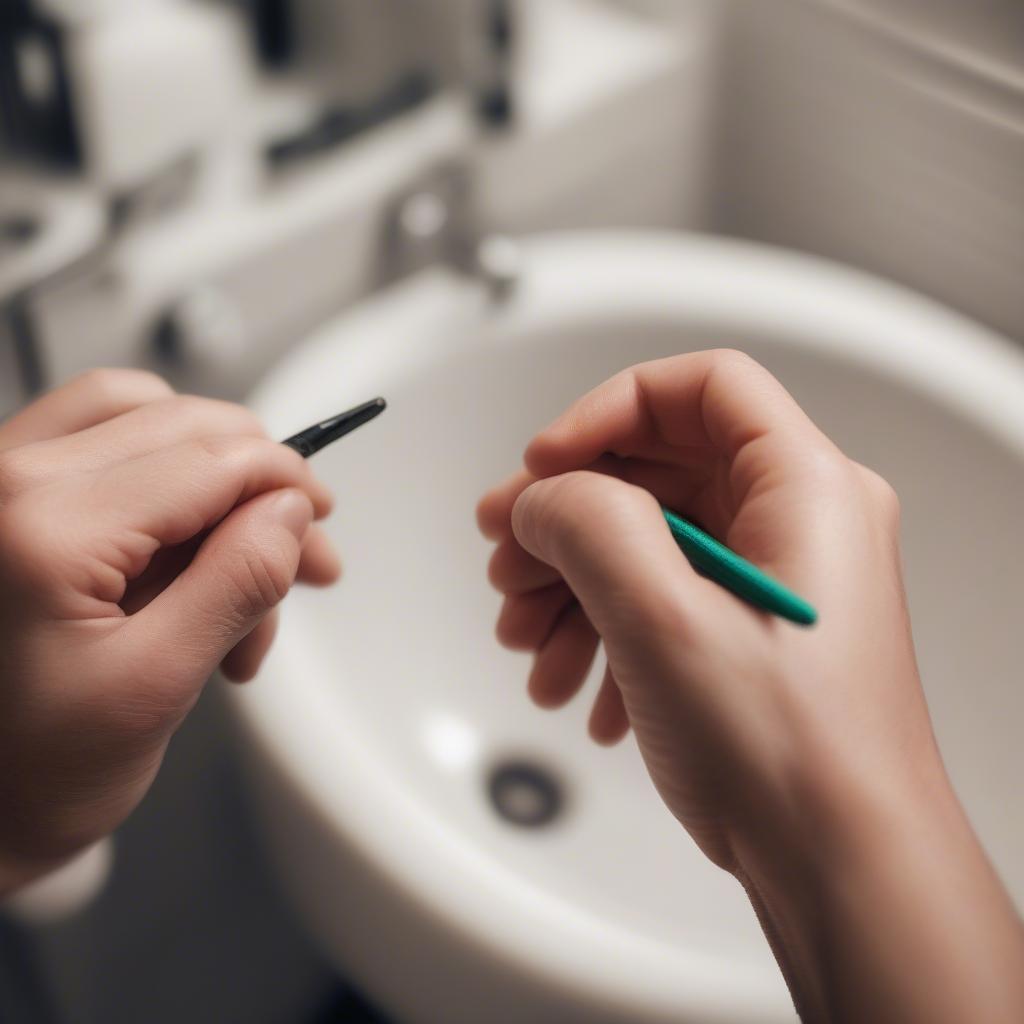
[79, 436, 331, 579]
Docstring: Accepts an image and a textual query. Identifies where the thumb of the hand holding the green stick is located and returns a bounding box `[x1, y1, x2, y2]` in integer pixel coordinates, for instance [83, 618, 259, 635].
[512, 471, 723, 653]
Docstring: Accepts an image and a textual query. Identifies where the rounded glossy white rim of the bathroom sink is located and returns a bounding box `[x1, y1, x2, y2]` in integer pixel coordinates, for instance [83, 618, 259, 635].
[232, 232, 1024, 1019]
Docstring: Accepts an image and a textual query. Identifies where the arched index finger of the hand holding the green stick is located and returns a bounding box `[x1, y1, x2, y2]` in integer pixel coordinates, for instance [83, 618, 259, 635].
[525, 350, 830, 485]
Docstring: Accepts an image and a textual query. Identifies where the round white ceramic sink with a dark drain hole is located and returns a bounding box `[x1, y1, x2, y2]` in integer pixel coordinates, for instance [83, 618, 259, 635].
[230, 233, 1024, 1024]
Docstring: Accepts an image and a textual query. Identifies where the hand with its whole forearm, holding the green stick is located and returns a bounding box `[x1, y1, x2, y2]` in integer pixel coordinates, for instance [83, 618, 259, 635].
[478, 352, 1024, 1021]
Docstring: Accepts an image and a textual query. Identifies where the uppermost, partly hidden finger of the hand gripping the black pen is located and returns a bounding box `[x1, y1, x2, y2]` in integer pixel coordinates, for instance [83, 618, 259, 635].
[0, 370, 174, 450]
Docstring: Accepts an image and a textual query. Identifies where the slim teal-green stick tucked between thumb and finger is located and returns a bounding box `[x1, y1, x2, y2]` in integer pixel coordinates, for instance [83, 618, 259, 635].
[662, 506, 818, 626]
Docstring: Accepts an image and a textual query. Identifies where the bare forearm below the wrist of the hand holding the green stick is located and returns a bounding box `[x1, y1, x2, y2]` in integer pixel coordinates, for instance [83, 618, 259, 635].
[737, 765, 1024, 1024]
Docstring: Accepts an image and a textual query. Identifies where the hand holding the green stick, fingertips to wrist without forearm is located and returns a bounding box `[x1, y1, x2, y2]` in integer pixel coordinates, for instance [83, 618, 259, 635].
[479, 352, 929, 869]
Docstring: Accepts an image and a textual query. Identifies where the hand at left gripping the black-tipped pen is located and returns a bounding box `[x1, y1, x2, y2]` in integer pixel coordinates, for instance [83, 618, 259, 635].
[0, 371, 339, 893]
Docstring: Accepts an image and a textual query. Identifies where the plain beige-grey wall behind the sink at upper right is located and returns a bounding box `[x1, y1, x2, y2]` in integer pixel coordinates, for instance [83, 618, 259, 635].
[713, 0, 1024, 340]
